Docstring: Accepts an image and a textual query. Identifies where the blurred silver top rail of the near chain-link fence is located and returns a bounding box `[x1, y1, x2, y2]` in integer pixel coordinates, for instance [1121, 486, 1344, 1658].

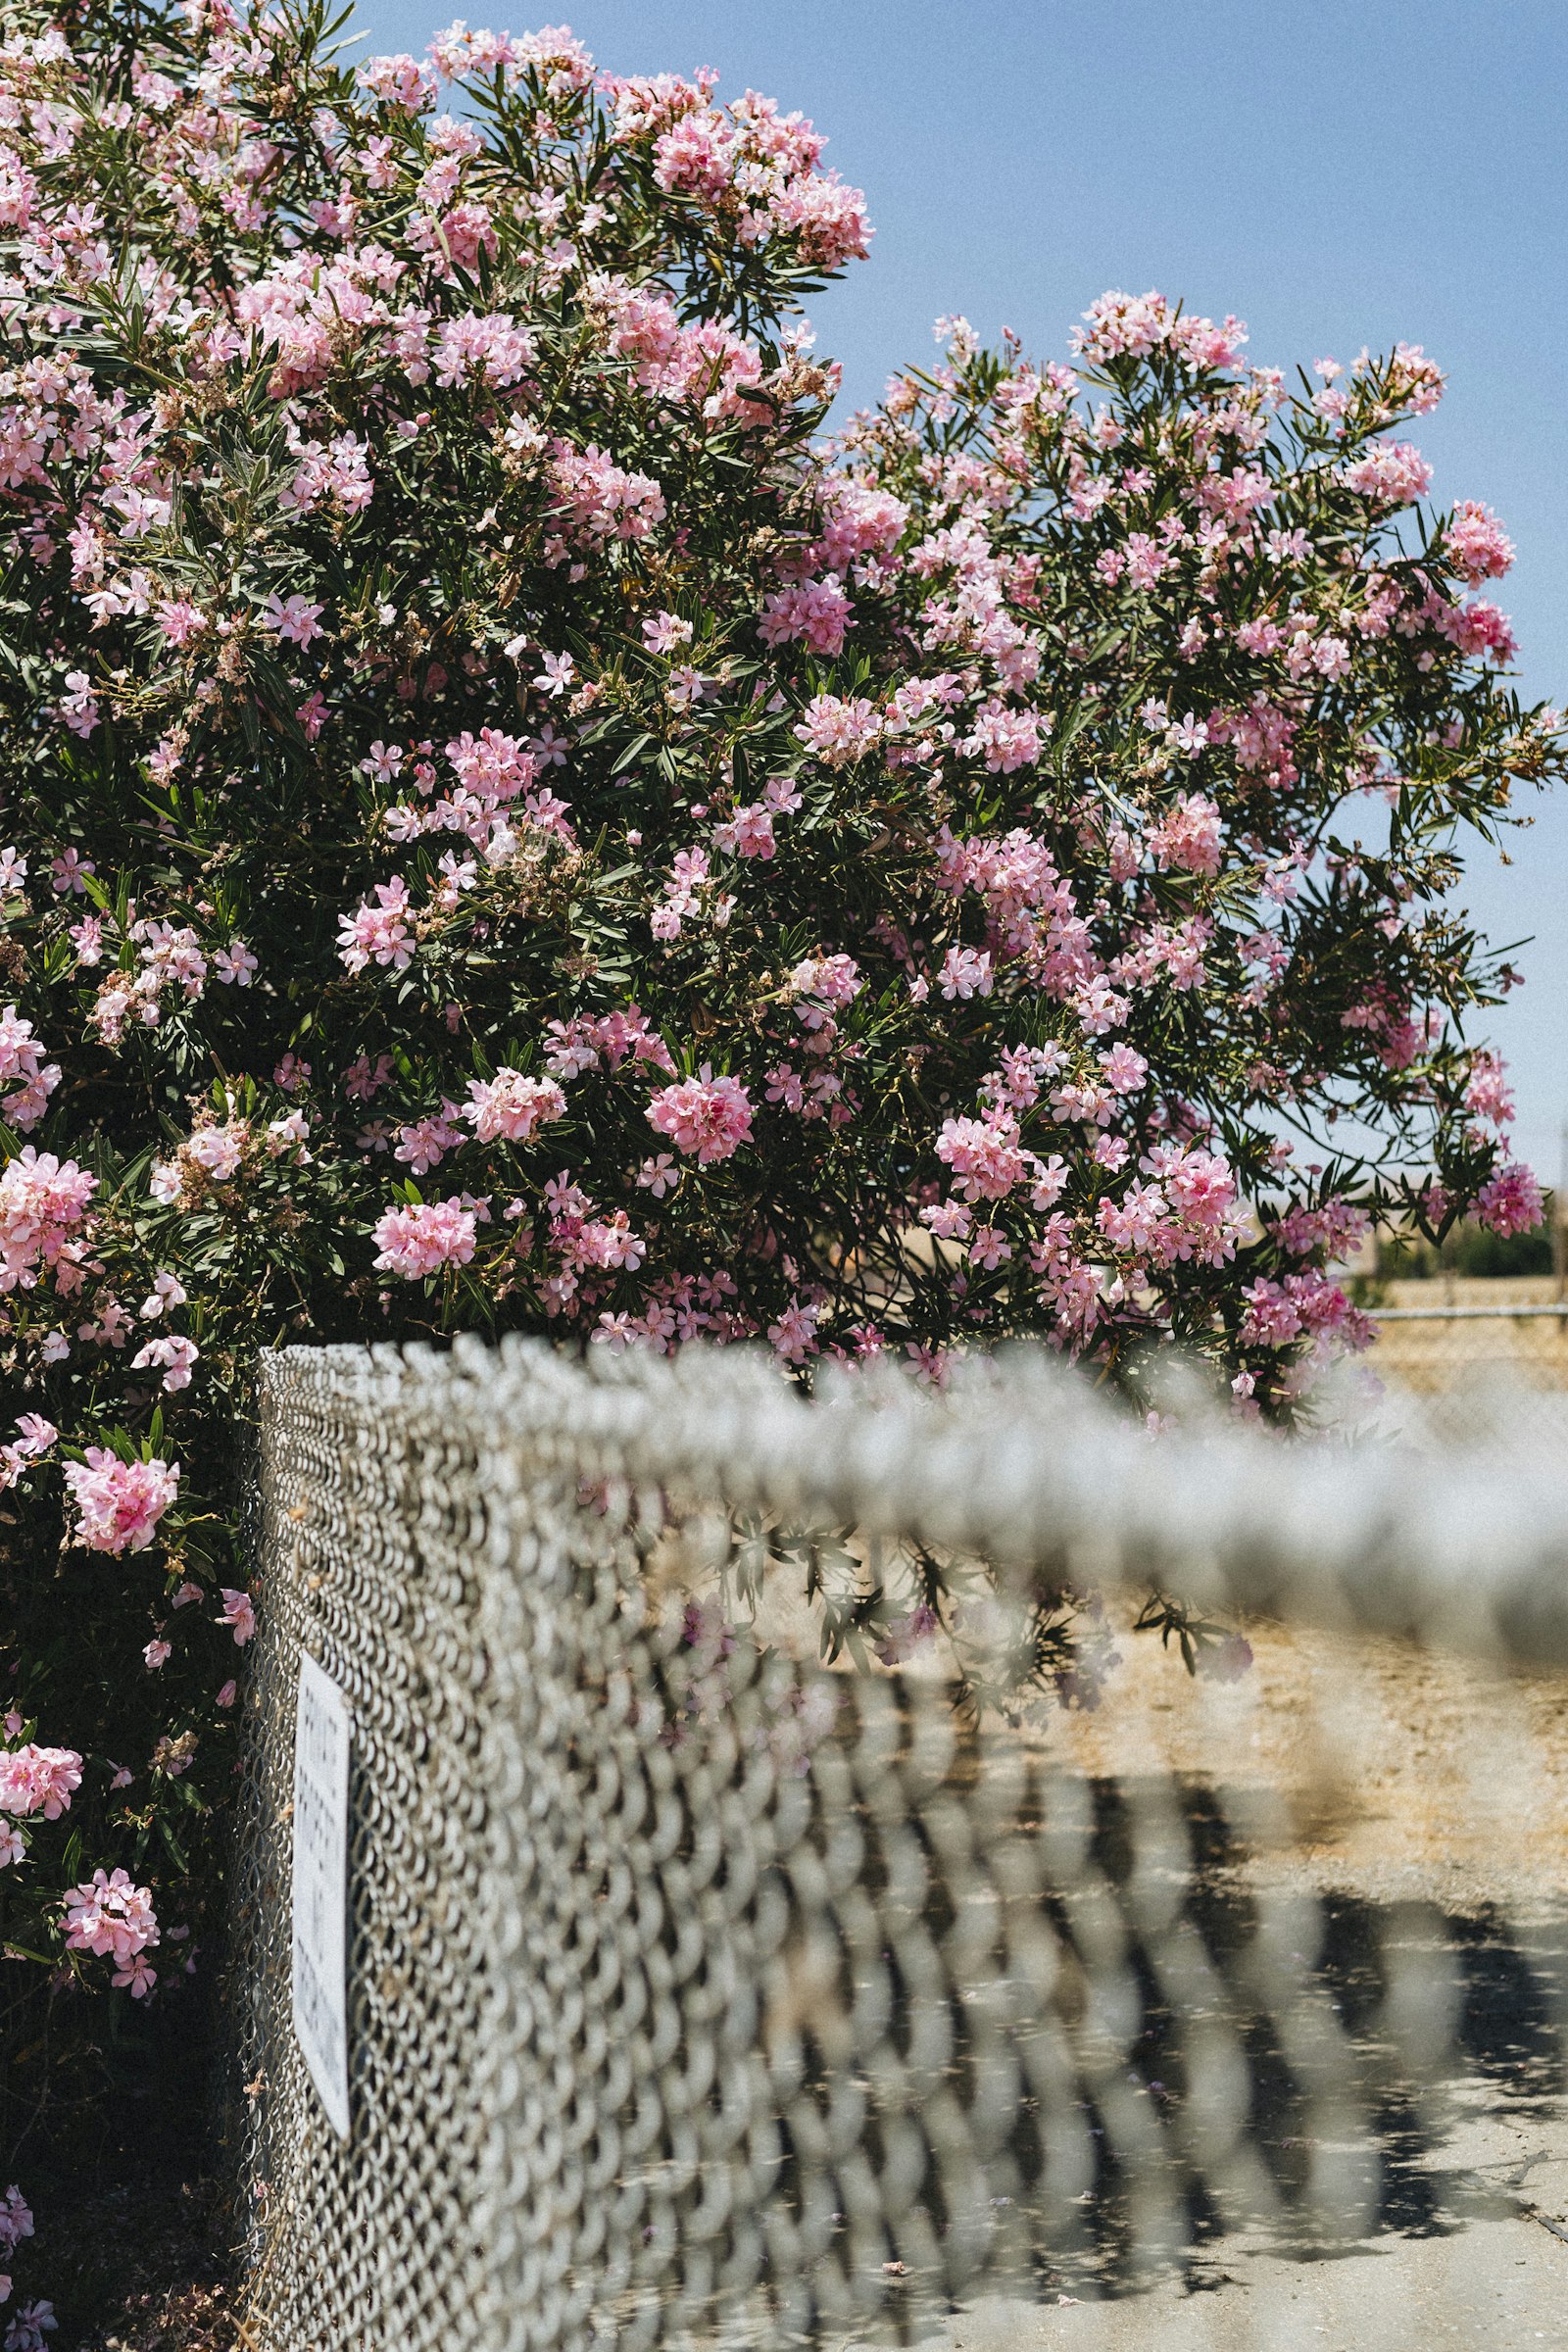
[264, 1339, 1568, 1668]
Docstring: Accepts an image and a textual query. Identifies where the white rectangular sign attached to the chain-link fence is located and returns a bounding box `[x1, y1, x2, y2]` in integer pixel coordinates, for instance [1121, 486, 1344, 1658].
[294, 1651, 350, 2140]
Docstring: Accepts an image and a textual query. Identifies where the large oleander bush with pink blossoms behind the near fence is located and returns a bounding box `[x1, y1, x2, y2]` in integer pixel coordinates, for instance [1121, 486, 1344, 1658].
[0, 0, 1566, 2314]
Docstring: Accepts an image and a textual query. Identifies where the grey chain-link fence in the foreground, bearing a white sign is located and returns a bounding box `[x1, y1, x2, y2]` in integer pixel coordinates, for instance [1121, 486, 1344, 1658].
[235, 1348, 1568, 2352]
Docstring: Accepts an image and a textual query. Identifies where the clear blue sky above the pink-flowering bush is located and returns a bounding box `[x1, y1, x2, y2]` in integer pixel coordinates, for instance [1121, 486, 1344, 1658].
[358, 0, 1568, 1181]
